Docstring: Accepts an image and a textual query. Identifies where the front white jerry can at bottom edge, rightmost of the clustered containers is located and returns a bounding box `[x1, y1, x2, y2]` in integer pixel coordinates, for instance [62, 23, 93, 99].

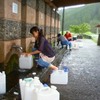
[37, 86, 60, 100]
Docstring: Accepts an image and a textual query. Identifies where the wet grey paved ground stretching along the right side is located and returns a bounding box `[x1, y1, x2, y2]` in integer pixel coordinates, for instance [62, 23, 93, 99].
[57, 40, 100, 100]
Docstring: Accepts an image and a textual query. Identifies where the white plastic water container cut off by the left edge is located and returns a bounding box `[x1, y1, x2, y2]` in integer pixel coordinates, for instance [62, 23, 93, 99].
[0, 71, 6, 94]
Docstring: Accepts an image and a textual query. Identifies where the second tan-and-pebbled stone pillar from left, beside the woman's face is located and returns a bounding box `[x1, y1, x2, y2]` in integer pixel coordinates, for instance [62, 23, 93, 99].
[21, 0, 37, 51]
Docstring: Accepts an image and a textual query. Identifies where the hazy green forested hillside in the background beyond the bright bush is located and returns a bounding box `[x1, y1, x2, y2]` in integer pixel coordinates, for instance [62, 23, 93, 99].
[59, 3, 100, 33]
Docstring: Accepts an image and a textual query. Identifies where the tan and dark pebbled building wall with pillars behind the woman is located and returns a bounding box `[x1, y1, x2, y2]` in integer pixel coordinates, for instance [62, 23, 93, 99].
[0, 0, 60, 63]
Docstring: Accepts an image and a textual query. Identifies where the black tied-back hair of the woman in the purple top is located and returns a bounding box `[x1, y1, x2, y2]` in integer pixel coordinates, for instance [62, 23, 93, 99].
[30, 26, 44, 45]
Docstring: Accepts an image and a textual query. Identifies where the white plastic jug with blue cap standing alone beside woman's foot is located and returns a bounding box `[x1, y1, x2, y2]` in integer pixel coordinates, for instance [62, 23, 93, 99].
[50, 70, 68, 84]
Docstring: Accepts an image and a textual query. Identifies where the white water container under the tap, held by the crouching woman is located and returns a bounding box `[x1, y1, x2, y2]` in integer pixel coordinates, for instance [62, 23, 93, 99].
[19, 55, 33, 69]
